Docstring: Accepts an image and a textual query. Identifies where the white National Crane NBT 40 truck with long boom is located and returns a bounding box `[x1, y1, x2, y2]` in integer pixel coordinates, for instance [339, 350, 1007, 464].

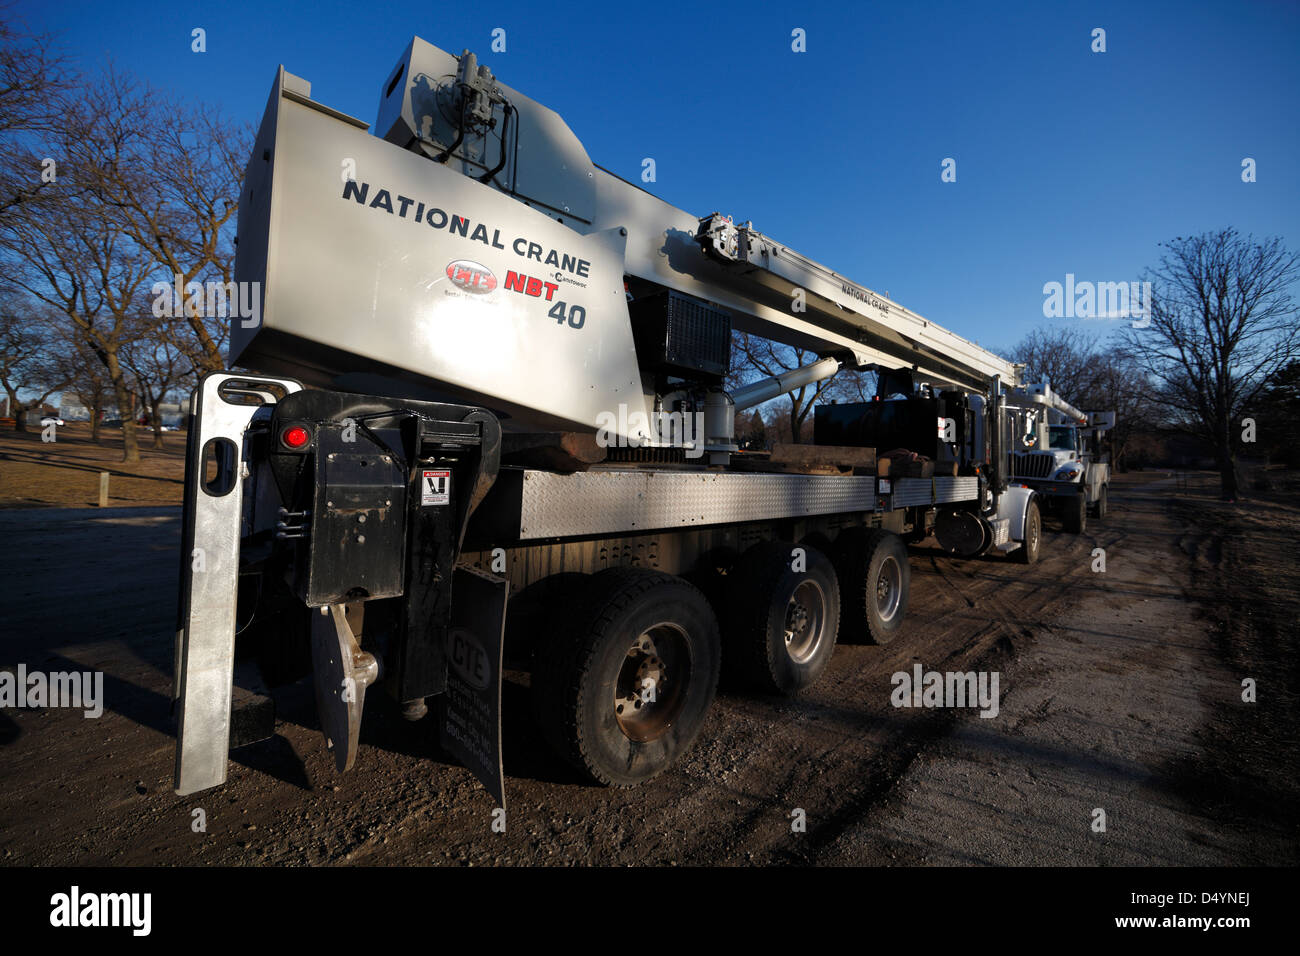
[165, 38, 1097, 806]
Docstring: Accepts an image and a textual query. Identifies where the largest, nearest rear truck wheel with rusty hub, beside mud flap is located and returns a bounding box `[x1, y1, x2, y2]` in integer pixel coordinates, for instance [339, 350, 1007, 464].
[533, 567, 720, 787]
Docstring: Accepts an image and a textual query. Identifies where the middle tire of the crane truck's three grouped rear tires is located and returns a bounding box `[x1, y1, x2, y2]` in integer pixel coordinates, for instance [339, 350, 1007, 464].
[723, 541, 840, 695]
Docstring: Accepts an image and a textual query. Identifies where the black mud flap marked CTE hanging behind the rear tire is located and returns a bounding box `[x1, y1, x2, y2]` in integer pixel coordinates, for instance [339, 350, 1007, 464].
[438, 567, 510, 809]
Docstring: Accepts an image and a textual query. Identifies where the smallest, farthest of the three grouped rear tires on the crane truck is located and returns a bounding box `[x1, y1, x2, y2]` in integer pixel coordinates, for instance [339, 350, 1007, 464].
[836, 528, 911, 644]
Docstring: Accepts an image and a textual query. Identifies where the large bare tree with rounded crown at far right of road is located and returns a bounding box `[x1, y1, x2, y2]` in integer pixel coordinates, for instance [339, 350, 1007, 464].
[1122, 229, 1300, 501]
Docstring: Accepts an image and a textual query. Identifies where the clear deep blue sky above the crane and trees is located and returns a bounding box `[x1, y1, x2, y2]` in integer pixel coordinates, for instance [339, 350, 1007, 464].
[17, 0, 1300, 356]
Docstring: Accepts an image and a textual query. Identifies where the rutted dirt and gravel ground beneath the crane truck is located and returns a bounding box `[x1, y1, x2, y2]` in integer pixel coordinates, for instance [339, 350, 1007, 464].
[0, 475, 1300, 865]
